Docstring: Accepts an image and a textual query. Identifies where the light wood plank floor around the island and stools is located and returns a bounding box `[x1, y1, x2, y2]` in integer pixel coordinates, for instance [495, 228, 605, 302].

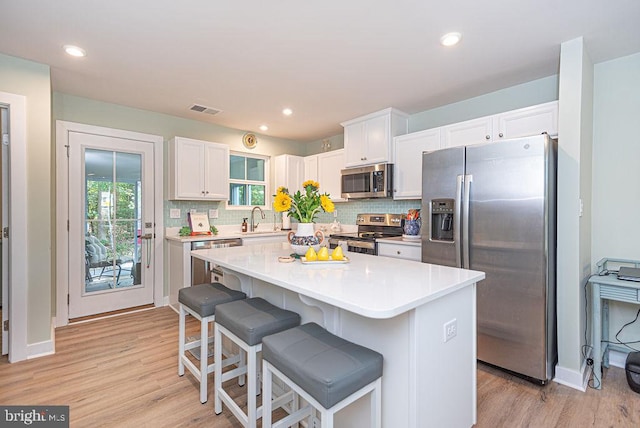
[0, 308, 640, 428]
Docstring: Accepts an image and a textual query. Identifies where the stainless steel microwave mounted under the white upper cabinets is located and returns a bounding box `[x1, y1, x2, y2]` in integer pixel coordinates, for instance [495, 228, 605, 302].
[341, 163, 393, 199]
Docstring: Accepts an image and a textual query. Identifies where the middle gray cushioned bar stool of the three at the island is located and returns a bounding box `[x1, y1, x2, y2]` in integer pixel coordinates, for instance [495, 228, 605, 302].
[214, 297, 300, 428]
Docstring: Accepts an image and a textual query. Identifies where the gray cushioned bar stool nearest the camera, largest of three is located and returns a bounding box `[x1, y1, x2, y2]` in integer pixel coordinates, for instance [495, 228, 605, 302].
[262, 323, 383, 428]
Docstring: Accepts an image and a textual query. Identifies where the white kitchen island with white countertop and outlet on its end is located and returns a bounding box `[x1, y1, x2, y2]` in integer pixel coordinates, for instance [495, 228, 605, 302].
[192, 243, 484, 427]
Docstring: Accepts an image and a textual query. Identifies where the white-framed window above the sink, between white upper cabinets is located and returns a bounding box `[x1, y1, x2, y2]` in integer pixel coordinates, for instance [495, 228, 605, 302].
[227, 152, 269, 209]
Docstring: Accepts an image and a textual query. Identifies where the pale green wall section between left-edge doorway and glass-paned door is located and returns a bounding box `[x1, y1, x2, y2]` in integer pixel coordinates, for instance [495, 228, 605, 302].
[0, 54, 55, 345]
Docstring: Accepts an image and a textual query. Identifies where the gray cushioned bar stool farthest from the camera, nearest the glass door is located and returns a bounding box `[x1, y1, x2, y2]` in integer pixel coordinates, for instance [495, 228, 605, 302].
[178, 282, 247, 403]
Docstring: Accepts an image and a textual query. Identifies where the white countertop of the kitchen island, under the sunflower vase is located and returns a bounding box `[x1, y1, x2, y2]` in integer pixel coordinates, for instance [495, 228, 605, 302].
[191, 243, 485, 319]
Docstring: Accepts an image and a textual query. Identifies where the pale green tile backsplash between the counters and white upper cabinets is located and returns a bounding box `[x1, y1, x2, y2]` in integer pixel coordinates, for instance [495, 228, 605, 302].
[164, 198, 421, 227]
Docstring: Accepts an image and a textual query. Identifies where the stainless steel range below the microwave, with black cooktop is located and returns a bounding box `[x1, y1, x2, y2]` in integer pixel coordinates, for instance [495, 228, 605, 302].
[329, 214, 404, 255]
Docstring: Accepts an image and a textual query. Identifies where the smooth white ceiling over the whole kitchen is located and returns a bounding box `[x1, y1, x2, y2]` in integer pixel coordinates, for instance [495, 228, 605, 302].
[0, 0, 640, 142]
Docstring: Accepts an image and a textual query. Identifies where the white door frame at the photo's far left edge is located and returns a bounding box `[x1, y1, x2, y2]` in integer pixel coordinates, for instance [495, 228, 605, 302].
[0, 92, 28, 363]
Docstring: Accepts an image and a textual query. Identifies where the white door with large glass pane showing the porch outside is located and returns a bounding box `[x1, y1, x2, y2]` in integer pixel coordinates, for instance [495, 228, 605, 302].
[69, 132, 154, 319]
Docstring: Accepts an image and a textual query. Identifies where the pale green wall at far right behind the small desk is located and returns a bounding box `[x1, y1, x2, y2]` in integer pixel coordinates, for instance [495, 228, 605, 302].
[592, 53, 640, 346]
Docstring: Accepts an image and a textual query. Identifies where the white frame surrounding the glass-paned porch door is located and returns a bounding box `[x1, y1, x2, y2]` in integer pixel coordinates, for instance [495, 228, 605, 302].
[55, 120, 165, 327]
